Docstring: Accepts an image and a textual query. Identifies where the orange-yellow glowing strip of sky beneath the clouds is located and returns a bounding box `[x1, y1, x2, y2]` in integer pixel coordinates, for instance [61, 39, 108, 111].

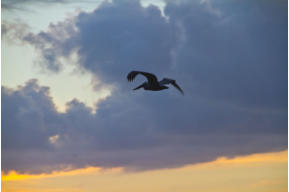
[1, 150, 288, 192]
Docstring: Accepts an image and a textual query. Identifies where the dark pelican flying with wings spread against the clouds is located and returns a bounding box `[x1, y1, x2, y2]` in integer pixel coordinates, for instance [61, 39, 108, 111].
[127, 71, 184, 95]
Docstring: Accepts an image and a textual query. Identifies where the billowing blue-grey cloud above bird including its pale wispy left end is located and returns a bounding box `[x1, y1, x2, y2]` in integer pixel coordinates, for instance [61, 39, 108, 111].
[24, 1, 174, 83]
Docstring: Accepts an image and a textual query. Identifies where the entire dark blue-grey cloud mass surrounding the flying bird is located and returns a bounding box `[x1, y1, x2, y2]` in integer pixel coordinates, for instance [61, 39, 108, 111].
[2, 1, 288, 172]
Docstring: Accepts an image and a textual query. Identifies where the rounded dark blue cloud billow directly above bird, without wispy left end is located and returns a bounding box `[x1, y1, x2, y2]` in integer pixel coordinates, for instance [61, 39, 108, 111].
[76, 1, 174, 83]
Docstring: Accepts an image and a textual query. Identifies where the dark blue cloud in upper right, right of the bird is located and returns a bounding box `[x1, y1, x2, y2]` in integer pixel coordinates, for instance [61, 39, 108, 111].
[165, 1, 288, 110]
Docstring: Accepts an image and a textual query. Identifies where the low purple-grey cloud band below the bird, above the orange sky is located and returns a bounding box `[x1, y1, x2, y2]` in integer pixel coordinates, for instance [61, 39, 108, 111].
[2, 80, 287, 173]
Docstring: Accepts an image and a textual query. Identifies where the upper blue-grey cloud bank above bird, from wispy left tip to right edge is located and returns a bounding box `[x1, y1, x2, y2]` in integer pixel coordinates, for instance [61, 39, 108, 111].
[24, 1, 288, 110]
